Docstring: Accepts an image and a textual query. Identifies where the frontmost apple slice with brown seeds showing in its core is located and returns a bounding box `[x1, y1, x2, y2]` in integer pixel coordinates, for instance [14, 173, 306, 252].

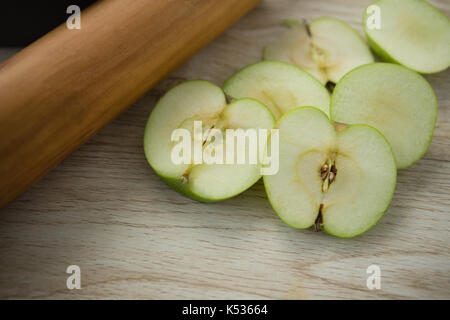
[264, 107, 397, 238]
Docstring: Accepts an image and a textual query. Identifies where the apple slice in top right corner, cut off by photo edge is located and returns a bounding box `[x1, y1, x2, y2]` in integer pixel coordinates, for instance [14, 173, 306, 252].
[363, 0, 450, 73]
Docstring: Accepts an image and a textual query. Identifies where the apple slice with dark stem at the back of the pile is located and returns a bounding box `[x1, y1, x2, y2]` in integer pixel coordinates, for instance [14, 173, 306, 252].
[263, 17, 374, 84]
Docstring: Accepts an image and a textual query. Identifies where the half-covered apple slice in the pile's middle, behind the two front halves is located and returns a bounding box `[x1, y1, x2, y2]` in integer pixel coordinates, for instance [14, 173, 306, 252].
[223, 61, 330, 119]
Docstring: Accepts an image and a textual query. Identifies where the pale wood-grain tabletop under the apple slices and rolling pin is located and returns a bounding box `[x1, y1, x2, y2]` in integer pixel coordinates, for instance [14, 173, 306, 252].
[0, 0, 450, 299]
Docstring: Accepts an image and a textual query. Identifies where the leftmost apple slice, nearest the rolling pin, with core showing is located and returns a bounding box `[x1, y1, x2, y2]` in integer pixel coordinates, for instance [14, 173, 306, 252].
[144, 80, 275, 201]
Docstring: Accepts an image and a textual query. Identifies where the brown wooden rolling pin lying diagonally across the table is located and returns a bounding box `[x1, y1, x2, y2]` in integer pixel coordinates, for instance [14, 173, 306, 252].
[0, 0, 259, 208]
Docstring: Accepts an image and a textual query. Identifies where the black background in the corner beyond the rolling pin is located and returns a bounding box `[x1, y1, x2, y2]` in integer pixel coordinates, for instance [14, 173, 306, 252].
[0, 0, 95, 47]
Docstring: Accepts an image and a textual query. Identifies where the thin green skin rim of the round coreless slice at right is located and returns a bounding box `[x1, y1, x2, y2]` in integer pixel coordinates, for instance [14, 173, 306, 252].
[330, 62, 438, 169]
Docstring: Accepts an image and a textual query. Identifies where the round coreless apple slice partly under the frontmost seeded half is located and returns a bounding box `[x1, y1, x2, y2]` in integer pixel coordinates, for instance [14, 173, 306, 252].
[330, 63, 437, 169]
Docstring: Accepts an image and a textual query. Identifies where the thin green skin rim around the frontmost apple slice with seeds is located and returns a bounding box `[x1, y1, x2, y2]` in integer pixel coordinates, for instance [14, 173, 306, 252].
[263, 106, 397, 239]
